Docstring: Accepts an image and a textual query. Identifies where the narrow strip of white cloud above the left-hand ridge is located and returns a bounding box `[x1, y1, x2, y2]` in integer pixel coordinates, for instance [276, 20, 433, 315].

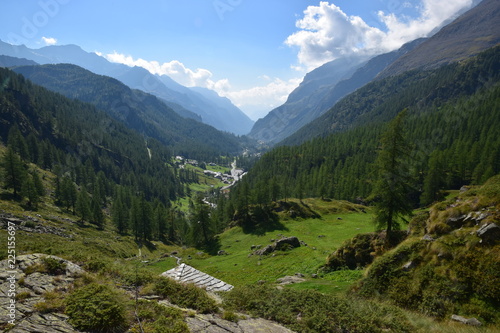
[104, 52, 229, 91]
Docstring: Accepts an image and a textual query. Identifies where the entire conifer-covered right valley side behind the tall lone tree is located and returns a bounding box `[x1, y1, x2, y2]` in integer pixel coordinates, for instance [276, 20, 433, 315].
[228, 47, 500, 210]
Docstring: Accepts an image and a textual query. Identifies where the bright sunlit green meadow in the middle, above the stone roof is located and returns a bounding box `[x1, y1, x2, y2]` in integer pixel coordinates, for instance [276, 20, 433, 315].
[151, 199, 373, 293]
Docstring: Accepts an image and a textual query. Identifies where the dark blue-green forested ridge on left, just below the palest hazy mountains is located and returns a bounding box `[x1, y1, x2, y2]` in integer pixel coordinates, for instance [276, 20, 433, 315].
[14, 64, 250, 156]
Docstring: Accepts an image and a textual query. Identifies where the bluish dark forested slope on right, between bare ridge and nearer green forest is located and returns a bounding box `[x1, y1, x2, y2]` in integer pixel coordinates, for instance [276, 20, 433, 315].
[281, 47, 500, 145]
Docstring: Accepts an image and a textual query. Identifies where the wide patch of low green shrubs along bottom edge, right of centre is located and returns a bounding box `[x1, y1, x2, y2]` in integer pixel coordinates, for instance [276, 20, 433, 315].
[224, 285, 412, 333]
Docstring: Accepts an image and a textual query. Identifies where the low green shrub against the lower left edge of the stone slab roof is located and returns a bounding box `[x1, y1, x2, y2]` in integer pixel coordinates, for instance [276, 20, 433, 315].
[154, 278, 219, 313]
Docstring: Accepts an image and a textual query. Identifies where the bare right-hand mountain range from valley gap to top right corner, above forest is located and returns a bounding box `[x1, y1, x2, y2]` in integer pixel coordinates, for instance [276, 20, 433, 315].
[249, 0, 500, 144]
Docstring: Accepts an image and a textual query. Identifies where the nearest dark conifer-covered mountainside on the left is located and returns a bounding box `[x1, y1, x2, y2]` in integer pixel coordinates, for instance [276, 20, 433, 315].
[0, 68, 184, 204]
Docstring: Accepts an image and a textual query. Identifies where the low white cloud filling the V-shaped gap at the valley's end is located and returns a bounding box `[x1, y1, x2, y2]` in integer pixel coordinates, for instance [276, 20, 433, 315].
[218, 75, 302, 120]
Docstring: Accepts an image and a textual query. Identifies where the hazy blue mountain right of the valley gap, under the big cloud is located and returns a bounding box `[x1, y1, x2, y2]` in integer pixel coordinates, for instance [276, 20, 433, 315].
[249, 56, 367, 143]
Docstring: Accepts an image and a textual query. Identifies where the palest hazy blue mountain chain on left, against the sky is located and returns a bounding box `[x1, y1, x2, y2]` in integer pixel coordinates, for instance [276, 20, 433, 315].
[0, 41, 253, 135]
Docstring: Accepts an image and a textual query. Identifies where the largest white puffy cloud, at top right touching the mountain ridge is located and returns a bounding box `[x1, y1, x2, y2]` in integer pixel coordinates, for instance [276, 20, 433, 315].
[285, 0, 473, 70]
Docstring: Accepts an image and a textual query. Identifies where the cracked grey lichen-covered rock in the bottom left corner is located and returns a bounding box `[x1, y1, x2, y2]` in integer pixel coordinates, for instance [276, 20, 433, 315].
[0, 253, 84, 333]
